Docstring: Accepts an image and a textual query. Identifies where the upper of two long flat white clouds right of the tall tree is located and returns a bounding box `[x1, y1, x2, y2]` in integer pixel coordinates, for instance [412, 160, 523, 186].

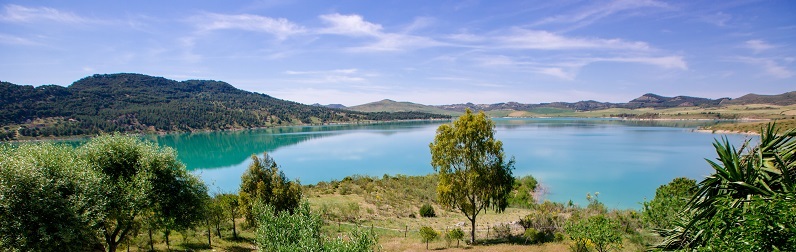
[497, 28, 650, 51]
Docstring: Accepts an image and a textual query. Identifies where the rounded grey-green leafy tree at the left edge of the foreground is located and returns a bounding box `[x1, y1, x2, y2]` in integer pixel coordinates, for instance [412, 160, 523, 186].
[0, 143, 107, 251]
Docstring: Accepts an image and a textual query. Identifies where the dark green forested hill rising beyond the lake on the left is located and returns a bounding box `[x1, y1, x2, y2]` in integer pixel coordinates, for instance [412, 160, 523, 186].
[0, 73, 449, 140]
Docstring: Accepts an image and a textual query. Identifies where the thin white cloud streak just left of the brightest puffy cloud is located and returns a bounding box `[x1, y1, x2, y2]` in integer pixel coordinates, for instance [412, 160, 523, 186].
[193, 13, 306, 39]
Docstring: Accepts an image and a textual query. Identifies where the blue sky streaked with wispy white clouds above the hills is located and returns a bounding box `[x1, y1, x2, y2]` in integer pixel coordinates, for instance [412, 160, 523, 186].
[0, 0, 796, 106]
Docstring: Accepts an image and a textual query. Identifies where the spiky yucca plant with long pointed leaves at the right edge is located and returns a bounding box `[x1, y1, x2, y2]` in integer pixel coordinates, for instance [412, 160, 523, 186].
[658, 123, 796, 249]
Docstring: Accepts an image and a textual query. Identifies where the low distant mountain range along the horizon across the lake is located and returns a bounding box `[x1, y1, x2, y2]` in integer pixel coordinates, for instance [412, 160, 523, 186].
[346, 91, 796, 115]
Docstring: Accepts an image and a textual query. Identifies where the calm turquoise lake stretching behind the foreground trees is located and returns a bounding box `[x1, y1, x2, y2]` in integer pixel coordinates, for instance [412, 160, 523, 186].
[146, 118, 749, 209]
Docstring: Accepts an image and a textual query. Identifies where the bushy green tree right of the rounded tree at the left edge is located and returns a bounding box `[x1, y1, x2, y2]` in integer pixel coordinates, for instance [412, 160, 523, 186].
[78, 135, 207, 251]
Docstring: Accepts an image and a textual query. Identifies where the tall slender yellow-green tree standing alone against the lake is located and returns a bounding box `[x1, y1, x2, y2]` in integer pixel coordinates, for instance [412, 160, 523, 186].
[429, 109, 514, 243]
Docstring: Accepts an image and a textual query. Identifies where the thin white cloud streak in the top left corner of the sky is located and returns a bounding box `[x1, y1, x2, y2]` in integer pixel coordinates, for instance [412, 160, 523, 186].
[0, 4, 91, 24]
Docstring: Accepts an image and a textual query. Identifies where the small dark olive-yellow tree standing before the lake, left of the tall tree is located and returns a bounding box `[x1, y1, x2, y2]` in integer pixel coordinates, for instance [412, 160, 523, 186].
[238, 153, 301, 226]
